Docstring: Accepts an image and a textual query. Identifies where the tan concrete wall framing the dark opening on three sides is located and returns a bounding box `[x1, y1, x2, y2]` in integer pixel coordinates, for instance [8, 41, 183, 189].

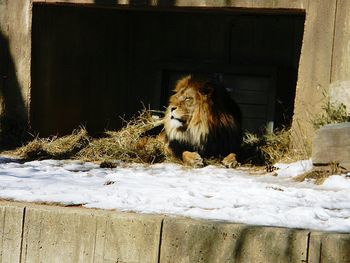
[0, 0, 350, 149]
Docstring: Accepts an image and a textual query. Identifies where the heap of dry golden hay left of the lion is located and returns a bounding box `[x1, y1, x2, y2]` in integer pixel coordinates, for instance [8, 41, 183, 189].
[14, 110, 166, 163]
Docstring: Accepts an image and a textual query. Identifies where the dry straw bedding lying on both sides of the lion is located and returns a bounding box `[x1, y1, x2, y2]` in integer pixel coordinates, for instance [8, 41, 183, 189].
[13, 109, 304, 167]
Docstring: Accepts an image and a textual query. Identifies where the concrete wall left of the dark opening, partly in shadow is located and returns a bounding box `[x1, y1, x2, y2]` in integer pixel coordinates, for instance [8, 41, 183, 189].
[0, 0, 32, 146]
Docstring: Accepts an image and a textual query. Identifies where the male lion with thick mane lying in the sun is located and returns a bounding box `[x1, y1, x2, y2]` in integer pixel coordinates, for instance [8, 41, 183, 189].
[164, 75, 242, 167]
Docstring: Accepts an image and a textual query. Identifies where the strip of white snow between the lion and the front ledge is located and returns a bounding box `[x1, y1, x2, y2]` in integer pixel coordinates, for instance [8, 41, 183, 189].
[0, 157, 350, 232]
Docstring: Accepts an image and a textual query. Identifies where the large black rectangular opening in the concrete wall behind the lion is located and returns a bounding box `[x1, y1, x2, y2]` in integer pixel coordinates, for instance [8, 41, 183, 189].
[31, 4, 305, 136]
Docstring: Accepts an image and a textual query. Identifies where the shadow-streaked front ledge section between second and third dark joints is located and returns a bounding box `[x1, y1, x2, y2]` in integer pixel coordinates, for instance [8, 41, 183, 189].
[160, 218, 309, 263]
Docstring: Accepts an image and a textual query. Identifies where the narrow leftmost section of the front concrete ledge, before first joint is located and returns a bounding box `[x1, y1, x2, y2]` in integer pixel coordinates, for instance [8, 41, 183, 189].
[0, 206, 24, 262]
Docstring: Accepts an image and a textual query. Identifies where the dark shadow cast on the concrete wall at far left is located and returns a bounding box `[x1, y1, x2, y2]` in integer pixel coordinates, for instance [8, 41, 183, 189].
[0, 31, 27, 150]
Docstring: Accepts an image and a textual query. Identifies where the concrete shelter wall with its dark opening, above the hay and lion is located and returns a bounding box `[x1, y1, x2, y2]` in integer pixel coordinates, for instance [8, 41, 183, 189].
[0, 0, 350, 150]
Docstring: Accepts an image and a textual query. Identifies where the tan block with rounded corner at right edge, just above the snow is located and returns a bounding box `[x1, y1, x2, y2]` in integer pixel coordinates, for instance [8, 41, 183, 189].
[312, 122, 350, 170]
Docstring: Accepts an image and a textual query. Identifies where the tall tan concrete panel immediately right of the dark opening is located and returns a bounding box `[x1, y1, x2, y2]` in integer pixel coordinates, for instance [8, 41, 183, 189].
[292, 0, 337, 150]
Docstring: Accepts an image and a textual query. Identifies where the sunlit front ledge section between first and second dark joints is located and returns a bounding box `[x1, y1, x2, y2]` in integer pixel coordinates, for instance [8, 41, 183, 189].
[18, 205, 162, 263]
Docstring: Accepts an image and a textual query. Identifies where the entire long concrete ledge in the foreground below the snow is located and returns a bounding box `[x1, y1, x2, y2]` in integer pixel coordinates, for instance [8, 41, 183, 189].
[0, 201, 350, 263]
